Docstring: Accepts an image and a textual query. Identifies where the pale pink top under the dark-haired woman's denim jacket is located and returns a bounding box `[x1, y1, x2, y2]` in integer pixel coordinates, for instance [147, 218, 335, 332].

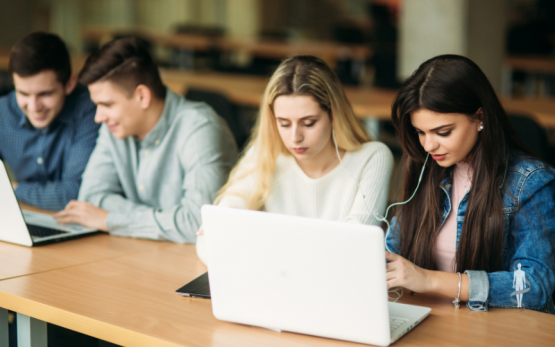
[434, 162, 472, 272]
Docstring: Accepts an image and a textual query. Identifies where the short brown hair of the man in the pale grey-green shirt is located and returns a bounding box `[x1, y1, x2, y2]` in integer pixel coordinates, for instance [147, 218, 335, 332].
[79, 37, 166, 99]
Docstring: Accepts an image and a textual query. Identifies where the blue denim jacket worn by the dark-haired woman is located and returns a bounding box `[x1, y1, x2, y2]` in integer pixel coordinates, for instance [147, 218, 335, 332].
[386, 156, 555, 314]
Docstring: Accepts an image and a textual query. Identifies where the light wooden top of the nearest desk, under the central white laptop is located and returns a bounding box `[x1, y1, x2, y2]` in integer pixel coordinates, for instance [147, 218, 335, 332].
[0, 245, 555, 347]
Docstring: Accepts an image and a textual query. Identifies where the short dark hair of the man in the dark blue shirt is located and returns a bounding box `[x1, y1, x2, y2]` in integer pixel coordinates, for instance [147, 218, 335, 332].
[8, 32, 71, 85]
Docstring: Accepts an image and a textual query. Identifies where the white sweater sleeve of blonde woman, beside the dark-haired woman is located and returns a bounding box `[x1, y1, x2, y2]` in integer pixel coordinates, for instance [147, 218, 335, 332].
[343, 142, 393, 225]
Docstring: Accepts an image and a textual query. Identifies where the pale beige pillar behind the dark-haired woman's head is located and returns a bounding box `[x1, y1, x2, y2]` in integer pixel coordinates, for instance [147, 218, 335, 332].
[398, 0, 509, 92]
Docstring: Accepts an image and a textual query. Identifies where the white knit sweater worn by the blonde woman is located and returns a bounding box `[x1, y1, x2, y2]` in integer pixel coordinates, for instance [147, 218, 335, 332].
[197, 141, 393, 263]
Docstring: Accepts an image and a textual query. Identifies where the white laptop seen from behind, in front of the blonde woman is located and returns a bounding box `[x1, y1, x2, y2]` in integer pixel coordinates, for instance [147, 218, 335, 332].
[201, 205, 431, 346]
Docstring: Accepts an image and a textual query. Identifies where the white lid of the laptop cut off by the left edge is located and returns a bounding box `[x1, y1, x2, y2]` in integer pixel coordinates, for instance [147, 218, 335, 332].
[0, 160, 33, 247]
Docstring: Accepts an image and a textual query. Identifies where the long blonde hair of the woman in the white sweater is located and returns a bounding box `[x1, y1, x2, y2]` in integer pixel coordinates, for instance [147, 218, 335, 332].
[216, 56, 370, 210]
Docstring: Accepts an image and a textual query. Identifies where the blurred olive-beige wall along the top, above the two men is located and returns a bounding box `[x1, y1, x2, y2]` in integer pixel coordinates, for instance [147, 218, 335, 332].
[43, 0, 261, 50]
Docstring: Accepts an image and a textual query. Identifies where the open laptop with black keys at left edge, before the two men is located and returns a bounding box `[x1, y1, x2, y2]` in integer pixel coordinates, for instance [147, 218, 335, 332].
[0, 160, 98, 247]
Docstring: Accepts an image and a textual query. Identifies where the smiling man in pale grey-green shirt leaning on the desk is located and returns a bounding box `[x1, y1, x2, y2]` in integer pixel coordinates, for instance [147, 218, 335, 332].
[55, 38, 237, 243]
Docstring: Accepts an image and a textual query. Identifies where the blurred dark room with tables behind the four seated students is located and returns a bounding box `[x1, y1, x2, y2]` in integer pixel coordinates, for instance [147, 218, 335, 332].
[0, 0, 555, 197]
